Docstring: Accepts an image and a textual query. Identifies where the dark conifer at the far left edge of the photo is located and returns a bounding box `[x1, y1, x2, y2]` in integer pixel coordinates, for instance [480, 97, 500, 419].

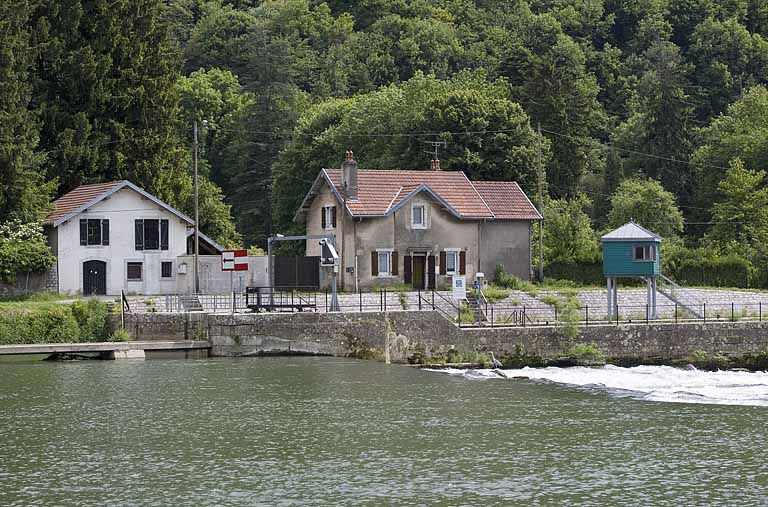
[0, 1, 56, 222]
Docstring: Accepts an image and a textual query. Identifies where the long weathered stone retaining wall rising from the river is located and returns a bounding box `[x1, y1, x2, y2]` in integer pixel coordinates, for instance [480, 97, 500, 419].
[121, 311, 768, 362]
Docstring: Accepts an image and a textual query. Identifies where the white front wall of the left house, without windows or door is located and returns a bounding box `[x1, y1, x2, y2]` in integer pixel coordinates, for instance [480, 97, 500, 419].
[52, 188, 187, 295]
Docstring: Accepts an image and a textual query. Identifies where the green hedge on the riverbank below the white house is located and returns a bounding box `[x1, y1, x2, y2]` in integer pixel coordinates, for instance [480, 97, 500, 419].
[0, 300, 110, 345]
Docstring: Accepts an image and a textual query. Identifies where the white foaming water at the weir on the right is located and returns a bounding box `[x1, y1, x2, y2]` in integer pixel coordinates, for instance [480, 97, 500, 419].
[433, 366, 768, 406]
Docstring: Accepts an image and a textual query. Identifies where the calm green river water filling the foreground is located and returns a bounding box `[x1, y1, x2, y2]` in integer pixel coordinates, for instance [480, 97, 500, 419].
[0, 358, 768, 507]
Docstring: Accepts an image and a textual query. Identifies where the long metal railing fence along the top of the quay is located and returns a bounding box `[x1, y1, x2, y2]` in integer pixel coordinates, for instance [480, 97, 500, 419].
[124, 287, 768, 327]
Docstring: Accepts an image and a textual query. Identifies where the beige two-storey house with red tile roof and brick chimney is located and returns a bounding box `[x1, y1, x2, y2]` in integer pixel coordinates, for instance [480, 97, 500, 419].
[294, 152, 542, 290]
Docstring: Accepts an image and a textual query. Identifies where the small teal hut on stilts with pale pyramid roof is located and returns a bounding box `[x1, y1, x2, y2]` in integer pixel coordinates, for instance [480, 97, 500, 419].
[600, 222, 661, 319]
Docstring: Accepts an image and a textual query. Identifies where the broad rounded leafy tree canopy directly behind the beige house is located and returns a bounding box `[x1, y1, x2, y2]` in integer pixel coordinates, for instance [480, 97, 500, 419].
[272, 73, 549, 233]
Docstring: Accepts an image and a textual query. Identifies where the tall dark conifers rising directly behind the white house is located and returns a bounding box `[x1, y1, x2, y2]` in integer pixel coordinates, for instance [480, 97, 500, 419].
[30, 0, 192, 203]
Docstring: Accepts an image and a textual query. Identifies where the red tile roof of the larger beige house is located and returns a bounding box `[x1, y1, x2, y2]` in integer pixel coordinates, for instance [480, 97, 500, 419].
[323, 169, 541, 220]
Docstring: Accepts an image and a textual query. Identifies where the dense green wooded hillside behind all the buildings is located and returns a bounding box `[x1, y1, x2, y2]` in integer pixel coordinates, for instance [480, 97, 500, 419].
[0, 0, 768, 286]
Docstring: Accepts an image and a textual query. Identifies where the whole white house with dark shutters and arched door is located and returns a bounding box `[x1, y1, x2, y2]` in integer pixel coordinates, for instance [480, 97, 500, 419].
[46, 181, 217, 295]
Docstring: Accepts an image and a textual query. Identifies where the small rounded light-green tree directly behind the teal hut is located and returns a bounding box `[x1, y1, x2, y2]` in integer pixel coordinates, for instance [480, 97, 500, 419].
[608, 179, 683, 237]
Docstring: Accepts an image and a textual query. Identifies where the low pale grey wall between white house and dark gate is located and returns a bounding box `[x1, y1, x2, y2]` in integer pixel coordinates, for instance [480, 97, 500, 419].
[175, 255, 269, 294]
